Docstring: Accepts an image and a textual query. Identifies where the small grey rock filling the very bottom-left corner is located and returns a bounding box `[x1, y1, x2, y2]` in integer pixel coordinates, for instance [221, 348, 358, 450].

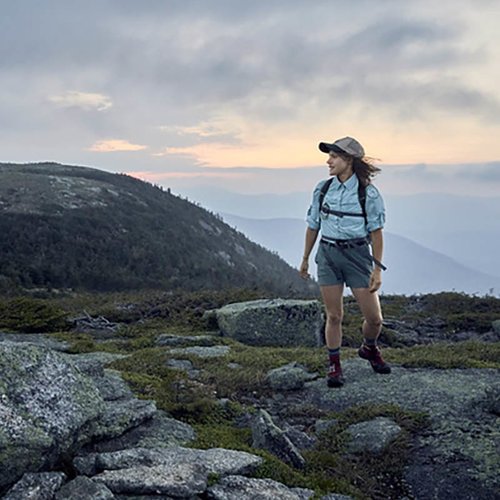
[2, 472, 66, 500]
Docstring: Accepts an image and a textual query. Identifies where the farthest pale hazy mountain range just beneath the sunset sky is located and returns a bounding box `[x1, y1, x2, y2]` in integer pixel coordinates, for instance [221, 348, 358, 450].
[184, 186, 500, 285]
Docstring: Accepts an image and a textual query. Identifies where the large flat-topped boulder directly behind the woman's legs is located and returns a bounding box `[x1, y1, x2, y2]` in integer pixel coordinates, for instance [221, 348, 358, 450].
[216, 299, 323, 347]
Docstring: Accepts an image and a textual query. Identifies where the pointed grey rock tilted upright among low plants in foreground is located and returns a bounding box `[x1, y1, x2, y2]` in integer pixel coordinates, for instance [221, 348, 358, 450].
[252, 410, 305, 469]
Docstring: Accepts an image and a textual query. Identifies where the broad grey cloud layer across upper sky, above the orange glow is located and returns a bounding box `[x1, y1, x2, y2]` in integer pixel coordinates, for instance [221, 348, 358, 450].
[0, 0, 500, 177]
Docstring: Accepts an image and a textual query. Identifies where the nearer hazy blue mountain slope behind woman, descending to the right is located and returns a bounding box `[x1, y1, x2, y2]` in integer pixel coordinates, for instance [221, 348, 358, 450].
[223, 214, 500, 295]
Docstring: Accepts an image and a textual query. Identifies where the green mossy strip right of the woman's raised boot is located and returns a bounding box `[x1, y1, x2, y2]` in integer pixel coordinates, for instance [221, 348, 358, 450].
[384, 341, 500, 369]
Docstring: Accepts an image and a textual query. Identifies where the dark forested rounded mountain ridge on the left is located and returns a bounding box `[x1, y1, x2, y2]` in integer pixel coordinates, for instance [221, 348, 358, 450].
[0, 163, 311, 296]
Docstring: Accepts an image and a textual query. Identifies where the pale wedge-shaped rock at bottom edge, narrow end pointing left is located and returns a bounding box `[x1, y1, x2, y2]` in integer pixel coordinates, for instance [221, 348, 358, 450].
[93, 463, 207, 498]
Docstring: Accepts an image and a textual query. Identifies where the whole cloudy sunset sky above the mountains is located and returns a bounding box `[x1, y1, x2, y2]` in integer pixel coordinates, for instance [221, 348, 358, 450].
[0, 0, 500, 196]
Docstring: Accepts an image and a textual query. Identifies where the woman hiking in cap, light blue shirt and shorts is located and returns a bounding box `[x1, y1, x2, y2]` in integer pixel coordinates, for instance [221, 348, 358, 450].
[300, 137, 391, 387]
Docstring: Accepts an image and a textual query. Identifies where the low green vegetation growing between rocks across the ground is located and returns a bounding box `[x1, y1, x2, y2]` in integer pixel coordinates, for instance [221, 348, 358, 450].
[0, 289, 500, 499]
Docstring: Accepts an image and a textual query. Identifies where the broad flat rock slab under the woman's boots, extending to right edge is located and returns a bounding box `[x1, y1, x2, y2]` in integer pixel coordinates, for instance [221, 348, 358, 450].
[304, 359, 500, 498]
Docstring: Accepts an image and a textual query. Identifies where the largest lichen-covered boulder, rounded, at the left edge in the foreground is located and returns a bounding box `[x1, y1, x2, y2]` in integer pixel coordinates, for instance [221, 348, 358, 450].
[0, 342, 104, 487]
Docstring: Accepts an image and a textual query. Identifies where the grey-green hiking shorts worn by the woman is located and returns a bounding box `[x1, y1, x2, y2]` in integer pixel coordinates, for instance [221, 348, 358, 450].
[314, 242, 373, 288]
